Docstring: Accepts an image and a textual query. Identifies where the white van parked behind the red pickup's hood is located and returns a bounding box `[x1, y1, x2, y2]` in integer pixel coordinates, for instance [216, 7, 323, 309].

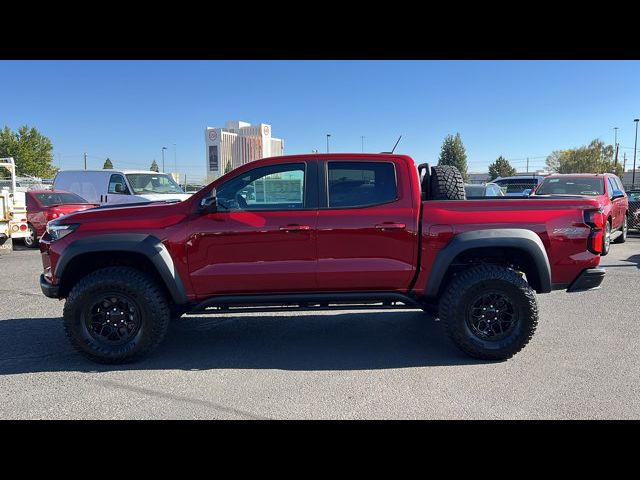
[53, 170, 191, 205]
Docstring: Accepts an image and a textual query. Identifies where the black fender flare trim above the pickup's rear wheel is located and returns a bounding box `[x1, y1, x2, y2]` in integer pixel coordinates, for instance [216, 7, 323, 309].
[424, 228, 552, 298]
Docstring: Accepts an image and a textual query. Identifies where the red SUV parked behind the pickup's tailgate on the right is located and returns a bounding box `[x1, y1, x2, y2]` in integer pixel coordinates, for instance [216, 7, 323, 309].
[531, 173, 629, 255]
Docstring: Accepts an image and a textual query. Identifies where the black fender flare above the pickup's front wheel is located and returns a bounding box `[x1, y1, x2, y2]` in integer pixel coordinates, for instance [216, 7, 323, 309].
[54, 233, 188, 304]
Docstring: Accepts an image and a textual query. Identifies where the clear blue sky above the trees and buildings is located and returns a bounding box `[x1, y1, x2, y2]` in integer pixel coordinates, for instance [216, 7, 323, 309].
[0, 61, 640, 179]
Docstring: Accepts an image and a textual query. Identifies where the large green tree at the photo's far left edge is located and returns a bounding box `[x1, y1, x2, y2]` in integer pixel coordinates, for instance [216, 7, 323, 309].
[0, 125, 58, 178]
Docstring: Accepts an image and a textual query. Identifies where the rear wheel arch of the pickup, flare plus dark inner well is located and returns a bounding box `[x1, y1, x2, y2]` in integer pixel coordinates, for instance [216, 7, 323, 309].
[424, 228, 552, 299]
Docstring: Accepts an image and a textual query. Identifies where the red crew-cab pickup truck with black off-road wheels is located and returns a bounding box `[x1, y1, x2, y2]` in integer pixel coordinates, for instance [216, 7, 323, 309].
[40, 154, 605, 363]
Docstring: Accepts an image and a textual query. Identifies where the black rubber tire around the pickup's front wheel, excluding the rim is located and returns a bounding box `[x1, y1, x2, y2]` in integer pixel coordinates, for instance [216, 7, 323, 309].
[63, 267, 170, 364]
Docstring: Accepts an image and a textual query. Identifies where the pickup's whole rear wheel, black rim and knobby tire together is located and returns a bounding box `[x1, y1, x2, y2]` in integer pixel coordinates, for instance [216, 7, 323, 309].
[439, 265, 538, 360]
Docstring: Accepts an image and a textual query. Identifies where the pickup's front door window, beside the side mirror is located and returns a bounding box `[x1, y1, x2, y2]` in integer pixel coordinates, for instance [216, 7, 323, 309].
[216, 163, 305, 211]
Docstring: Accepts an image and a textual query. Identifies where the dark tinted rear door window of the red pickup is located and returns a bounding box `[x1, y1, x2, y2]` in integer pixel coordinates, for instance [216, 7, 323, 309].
[327, 162, 398, 208]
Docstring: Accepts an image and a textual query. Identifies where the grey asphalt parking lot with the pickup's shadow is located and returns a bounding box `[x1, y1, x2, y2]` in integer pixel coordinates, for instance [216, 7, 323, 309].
[0, 234, 640, 419]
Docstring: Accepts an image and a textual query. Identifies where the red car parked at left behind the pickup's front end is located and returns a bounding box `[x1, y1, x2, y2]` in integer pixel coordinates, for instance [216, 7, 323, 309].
[24, 190, 98, 248]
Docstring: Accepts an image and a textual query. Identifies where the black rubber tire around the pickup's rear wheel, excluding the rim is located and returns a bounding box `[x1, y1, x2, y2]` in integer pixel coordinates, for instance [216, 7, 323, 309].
[439, 265, 538, 360]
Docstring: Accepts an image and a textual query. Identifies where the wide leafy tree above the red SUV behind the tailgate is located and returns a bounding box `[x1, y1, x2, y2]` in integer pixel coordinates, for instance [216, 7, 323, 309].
[546, 139, 623, 176]
